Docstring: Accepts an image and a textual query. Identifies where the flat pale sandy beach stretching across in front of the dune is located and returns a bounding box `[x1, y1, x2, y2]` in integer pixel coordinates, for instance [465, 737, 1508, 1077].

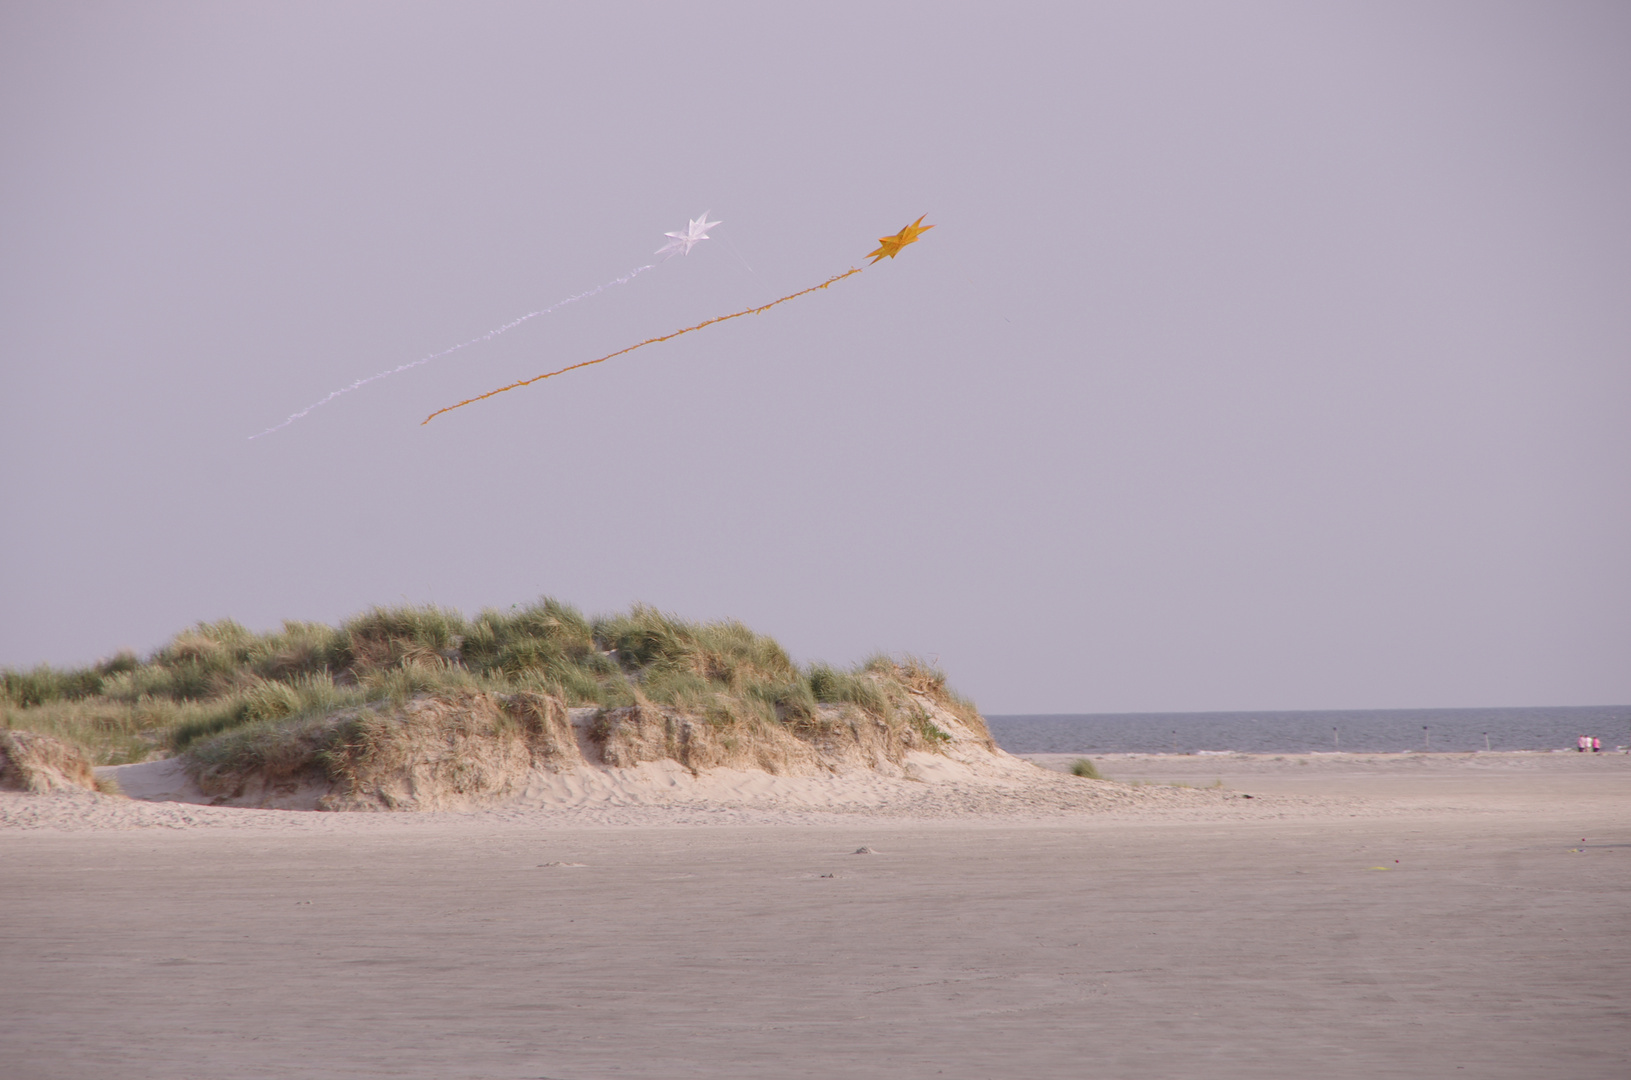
[0, 754, 1631, 1080]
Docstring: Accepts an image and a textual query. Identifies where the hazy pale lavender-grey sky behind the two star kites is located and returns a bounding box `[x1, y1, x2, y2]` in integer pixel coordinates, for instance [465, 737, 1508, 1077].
[0, 0, 1631, 713]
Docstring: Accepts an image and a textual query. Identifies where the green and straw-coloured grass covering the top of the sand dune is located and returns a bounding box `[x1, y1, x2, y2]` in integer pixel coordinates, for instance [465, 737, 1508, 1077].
[0, 599, 985, 765]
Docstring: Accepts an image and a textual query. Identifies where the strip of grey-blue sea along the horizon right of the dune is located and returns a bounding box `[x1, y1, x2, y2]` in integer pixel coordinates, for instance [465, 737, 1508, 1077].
[985, 705, 1631, 754]
